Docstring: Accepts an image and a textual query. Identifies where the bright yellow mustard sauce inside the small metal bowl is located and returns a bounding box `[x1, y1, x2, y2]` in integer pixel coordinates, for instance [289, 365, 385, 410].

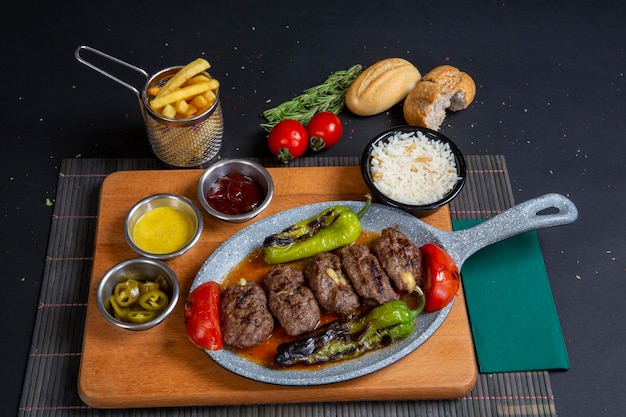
[133, 207, 195, 254]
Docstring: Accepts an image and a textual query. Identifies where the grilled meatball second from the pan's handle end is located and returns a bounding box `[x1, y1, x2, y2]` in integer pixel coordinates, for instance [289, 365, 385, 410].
[339, 243, 399, 306]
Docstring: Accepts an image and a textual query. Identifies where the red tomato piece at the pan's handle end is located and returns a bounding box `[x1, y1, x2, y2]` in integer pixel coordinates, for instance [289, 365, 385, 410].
[420, 243, 461, 312]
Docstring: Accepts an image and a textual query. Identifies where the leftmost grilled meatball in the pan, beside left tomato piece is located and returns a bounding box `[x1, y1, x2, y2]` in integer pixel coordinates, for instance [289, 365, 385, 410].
[221, 280, 274, 348]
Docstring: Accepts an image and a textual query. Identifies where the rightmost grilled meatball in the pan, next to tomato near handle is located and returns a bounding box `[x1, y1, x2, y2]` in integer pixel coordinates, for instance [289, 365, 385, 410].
[372, 227, 422, 292]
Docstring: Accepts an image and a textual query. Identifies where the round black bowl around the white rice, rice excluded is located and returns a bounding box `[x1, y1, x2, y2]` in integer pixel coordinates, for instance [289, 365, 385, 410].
[361, 126, 467, 217]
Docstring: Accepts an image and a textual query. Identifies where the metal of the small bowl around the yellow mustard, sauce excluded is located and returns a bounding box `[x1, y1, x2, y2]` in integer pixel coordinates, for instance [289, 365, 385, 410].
[124, 194, 203, 260]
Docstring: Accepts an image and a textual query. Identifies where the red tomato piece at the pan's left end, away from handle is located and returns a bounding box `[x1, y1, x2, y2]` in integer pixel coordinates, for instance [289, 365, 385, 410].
[185, 281, 224, 350]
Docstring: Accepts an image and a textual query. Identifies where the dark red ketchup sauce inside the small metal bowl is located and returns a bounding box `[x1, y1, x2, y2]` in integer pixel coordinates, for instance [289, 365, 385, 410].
[206, 172, 264, 215]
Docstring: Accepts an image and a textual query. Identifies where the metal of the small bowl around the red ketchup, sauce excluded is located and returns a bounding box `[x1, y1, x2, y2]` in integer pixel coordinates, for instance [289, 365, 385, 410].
[198, 159, 274, 223]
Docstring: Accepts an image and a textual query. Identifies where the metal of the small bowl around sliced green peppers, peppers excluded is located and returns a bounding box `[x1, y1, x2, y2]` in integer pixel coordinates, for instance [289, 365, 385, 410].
[96, 258, 180, 330]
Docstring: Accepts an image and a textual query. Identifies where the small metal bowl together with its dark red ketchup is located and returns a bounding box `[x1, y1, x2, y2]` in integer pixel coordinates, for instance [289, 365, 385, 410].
[198, 159, 274, 223]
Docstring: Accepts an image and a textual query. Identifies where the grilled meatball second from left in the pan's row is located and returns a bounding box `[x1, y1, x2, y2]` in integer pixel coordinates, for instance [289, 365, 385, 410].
[265, 264, 321, 336]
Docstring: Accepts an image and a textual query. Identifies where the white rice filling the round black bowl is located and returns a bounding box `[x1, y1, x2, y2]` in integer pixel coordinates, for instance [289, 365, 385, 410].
[371, 132, 459, 205]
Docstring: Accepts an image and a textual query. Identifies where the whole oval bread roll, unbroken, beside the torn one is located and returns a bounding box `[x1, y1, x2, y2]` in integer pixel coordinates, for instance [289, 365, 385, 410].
[346, 58, 422, 116]
